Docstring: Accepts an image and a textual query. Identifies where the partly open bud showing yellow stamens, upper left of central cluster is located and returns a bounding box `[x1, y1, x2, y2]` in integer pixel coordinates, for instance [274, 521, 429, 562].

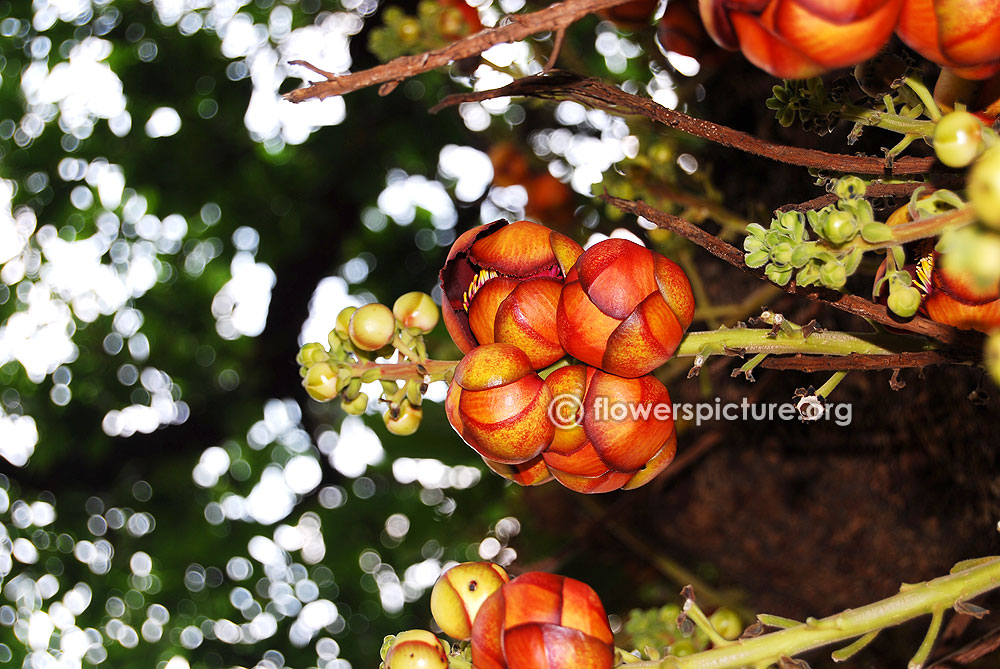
[441, 220, 583, 369]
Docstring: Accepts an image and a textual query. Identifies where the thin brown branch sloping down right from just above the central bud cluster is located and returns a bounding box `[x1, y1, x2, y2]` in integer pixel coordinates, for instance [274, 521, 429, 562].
[602, 194, 982, 352]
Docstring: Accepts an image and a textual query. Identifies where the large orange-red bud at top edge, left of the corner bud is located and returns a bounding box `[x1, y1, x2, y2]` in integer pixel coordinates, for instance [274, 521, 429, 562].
[699, 0, 903, 79]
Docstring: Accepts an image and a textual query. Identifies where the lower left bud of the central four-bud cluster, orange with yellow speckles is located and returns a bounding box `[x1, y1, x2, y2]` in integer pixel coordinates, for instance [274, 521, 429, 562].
[445, 344, 555, 465]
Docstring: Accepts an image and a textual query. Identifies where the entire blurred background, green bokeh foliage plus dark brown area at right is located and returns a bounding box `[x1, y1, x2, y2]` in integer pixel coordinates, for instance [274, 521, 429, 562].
[0, 0, 1000, 669]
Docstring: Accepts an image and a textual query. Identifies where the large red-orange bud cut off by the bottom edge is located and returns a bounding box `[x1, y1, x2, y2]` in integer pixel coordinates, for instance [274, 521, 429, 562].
[472, 572, 615, 669]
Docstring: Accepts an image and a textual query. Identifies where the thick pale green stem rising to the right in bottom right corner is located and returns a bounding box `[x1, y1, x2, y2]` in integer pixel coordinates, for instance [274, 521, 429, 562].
[632, 557, 1000, 669]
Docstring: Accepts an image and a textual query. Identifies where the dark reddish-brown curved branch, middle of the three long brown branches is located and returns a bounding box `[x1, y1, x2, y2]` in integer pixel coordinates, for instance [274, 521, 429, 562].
[431, 72, 934, 174]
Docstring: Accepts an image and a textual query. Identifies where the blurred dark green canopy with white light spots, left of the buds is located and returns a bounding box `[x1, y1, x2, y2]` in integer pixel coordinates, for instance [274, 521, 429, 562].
[0, 0, 720, 669]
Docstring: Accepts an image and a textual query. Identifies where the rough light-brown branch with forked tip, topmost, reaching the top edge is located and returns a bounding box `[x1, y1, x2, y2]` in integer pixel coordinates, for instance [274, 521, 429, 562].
[285, 0, 627, 102]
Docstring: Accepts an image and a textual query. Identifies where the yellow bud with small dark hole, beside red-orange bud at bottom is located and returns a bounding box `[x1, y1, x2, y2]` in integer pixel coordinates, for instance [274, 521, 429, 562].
[431, 562, 510, 639]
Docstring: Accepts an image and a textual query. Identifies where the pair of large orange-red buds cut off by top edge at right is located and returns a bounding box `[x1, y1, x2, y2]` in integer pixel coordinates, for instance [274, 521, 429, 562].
[699, 0, 1000, 79]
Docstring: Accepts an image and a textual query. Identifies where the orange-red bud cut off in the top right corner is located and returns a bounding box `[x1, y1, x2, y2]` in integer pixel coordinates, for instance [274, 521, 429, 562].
[896, 0, 1000, 79]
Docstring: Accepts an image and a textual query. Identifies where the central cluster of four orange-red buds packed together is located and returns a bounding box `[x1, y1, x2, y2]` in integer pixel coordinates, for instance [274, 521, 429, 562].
[441, 221, 694, 493]
